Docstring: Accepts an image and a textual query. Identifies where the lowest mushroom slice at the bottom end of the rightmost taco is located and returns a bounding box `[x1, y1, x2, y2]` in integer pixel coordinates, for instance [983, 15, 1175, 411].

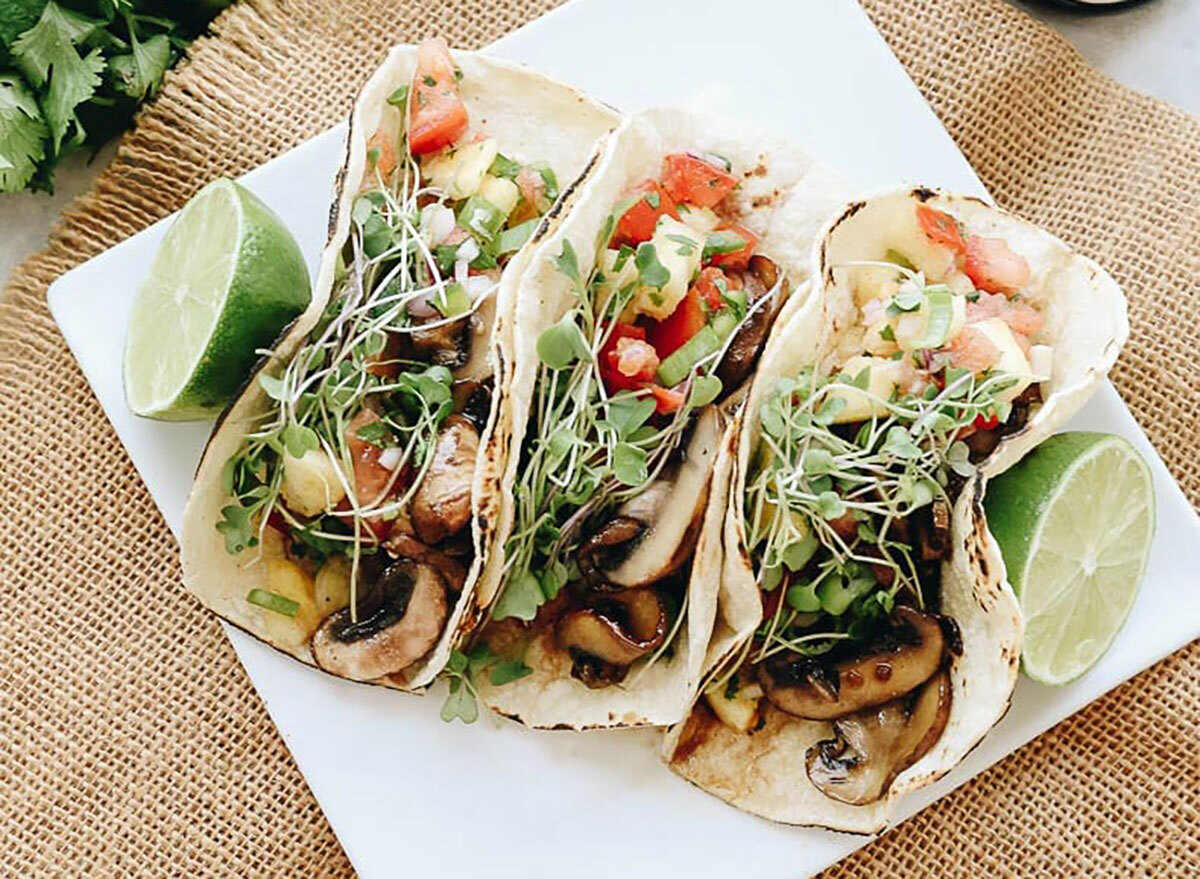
[805, 670, 950, 806]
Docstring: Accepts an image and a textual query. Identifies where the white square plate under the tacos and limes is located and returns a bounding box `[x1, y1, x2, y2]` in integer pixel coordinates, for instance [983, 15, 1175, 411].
[49, 0, 1200, 879]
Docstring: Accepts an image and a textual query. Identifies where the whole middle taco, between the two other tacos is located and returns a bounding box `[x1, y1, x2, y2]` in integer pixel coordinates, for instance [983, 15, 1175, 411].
[473, 110, 844, 729]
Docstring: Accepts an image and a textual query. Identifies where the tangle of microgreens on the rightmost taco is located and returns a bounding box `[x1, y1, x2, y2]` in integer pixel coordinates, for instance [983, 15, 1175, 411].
[745, 357, 1012, 660]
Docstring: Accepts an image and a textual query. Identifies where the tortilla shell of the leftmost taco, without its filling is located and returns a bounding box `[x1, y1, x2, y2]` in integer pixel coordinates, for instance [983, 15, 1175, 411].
[180, 46, 618, 689]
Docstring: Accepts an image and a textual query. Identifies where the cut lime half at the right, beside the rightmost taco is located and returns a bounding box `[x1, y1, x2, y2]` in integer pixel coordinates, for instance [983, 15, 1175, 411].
[984, 432, 1154, 684]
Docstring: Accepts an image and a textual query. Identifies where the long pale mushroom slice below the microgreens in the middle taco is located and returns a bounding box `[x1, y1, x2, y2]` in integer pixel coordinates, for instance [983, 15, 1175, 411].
[581, 408, 720, 587]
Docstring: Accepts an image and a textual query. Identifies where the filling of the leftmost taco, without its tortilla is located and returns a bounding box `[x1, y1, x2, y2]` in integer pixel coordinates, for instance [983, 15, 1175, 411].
[216, 40, 571, 682]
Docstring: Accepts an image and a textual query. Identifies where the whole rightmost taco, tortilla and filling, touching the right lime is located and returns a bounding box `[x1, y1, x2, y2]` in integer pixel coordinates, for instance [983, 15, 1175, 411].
[665, 189, 1128, 833]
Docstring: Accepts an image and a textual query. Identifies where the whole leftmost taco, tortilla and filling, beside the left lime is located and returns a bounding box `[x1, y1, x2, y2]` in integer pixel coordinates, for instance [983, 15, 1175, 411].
[181, 40, 617, 688]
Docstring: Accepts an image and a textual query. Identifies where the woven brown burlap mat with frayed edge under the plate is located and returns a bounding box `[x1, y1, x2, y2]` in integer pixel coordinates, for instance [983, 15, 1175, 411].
[0, 0, 1200, 878]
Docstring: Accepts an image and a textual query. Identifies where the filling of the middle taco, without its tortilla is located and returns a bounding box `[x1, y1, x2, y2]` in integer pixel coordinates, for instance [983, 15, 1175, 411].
[484, 153, 787, 688]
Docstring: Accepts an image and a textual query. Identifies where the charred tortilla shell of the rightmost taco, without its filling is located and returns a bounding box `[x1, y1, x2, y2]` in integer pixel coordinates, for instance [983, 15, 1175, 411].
[664, 189, 1128, 833]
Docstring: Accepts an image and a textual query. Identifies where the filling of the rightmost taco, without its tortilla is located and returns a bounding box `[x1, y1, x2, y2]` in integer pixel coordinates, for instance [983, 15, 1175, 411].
[696, 204, 1052, 805]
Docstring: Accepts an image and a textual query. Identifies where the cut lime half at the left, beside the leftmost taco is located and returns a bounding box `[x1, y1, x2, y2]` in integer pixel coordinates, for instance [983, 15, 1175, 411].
[125, 179, 311, 421]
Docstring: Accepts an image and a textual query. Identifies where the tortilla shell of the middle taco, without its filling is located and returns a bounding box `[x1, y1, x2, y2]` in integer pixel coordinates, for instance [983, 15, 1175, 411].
[475, 109, 848, 729]
